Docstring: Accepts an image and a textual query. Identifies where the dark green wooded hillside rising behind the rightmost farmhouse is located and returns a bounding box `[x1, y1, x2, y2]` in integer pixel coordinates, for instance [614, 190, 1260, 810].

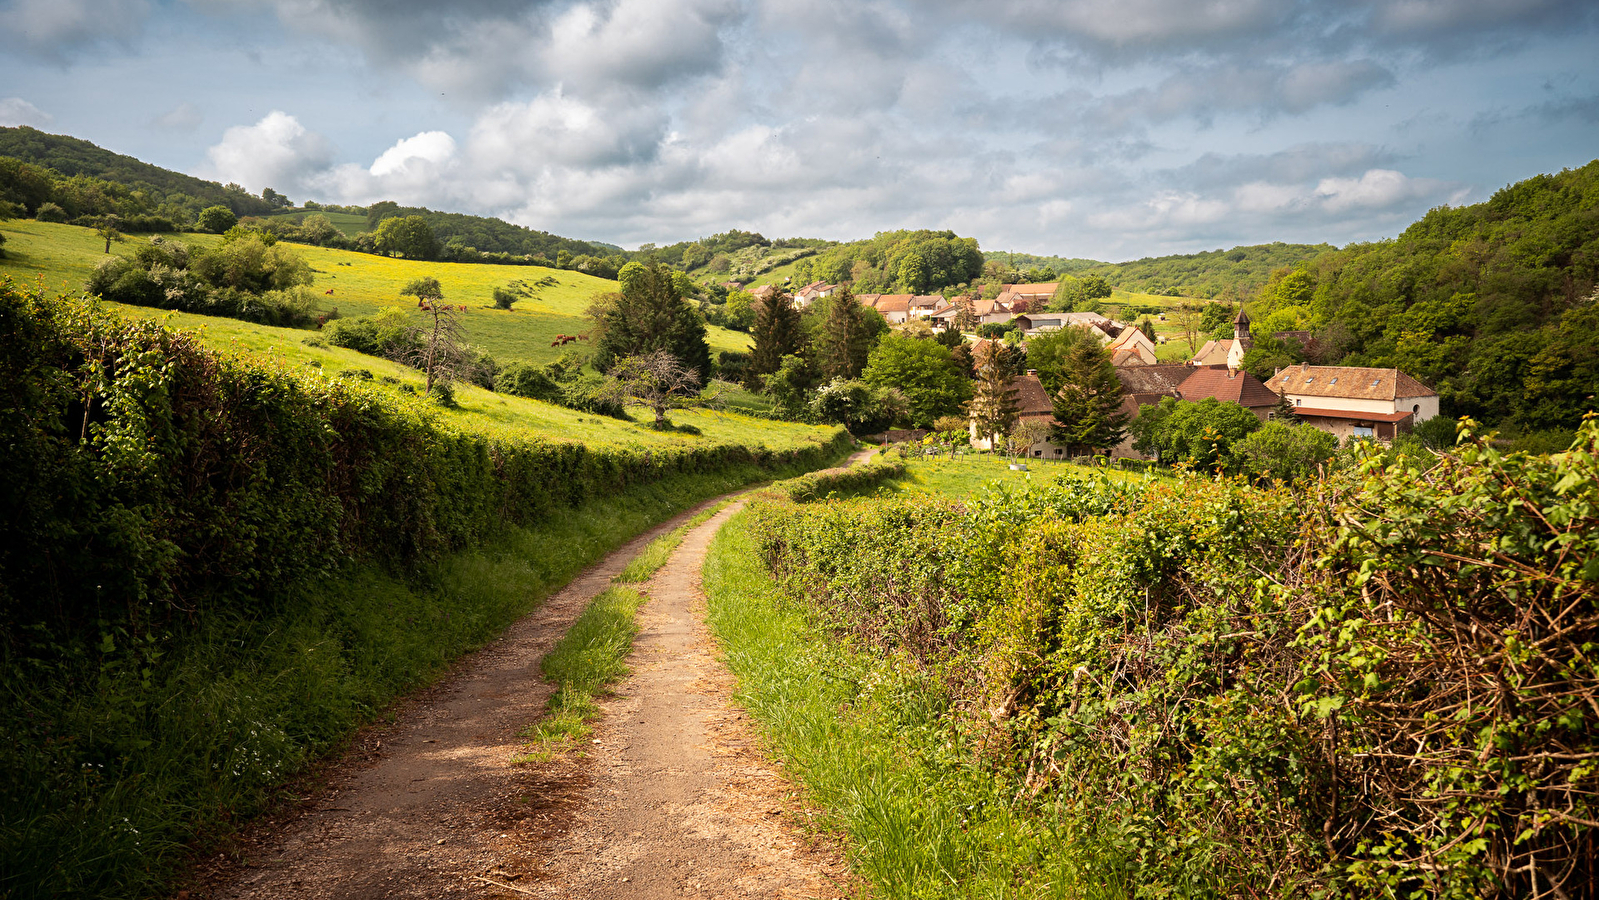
[1250, 161, 1599, 432]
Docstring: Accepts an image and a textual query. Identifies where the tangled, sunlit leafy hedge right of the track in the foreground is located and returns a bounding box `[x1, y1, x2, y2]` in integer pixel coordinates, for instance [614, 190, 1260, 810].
[755, 422, 1599, 898]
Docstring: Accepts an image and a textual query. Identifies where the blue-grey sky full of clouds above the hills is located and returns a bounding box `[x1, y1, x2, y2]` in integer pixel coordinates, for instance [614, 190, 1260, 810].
[0, 0, 1599, 261]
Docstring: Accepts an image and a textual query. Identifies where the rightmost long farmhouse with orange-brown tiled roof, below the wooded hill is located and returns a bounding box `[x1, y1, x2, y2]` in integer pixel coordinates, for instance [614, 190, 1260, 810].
[1266, 364, 1438, 441]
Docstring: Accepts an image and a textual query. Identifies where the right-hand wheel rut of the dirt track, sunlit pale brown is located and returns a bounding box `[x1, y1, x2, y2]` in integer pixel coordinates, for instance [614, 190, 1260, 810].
[521, 502, 846, 900]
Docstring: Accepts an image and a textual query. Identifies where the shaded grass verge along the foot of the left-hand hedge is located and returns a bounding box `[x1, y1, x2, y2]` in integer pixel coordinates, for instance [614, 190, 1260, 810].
[0, 467, 825, 900]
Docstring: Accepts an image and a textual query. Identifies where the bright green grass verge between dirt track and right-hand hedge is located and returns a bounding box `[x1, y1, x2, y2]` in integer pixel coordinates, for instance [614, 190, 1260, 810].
[704, 516, 1087, 900]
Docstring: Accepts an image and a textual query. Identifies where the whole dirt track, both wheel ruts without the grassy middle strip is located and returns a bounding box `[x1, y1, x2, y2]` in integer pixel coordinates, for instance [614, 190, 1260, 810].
[207, 473, 859, 900]
